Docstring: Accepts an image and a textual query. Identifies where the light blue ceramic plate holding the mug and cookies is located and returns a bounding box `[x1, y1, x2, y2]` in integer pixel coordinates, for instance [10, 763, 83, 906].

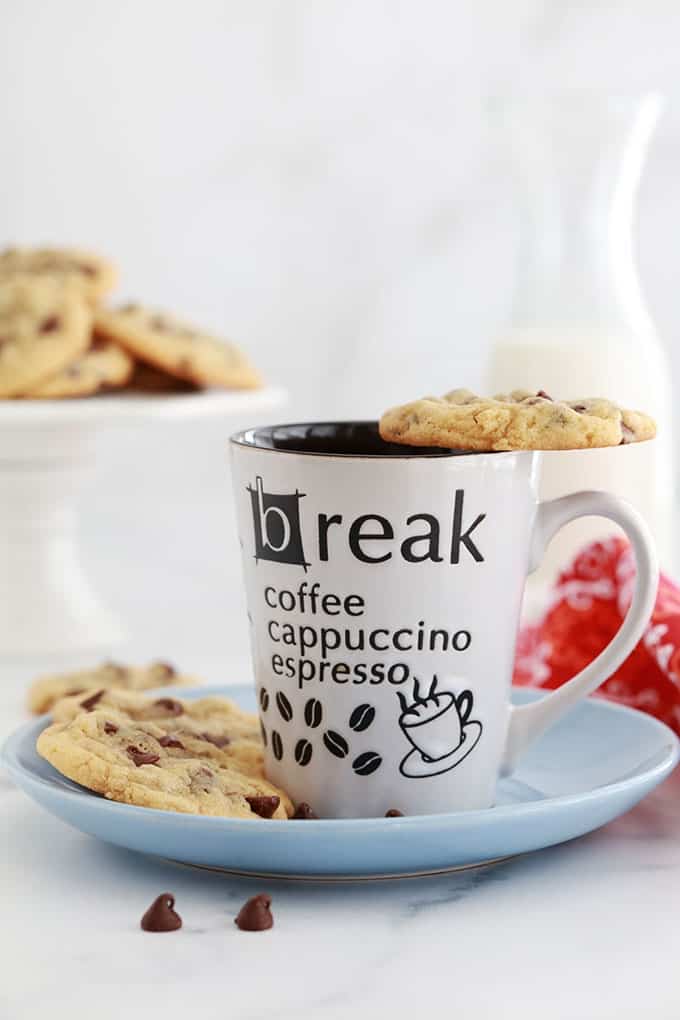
[2, 686, 678, 880]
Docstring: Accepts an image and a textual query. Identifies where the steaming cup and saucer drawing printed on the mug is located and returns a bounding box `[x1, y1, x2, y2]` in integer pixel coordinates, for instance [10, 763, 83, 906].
[398, 676, 482, 779]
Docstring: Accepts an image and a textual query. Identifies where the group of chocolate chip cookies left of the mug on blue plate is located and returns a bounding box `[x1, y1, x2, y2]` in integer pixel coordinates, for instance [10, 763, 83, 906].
[29, 663, 294, 819]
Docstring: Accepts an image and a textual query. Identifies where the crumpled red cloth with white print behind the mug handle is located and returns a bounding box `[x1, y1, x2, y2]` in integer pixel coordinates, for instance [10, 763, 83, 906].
[514, 539, 680, 733]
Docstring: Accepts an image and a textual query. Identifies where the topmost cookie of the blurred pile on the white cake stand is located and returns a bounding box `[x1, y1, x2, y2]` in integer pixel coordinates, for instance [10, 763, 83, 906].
[0, 248, 116, 303]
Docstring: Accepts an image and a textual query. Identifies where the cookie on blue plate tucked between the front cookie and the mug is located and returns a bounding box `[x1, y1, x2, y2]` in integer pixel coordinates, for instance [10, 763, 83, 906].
[52, 689, 264, 778]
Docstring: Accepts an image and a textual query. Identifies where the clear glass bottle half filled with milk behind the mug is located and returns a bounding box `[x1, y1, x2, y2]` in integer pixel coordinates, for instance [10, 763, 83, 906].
[486, 93, 674, 591]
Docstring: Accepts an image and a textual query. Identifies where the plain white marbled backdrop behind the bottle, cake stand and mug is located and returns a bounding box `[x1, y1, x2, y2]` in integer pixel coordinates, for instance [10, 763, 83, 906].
[0, 0, 680, 679]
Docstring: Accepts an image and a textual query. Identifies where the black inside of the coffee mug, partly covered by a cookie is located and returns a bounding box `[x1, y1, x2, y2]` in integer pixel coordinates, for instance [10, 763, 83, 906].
[233, 421, 471, 457]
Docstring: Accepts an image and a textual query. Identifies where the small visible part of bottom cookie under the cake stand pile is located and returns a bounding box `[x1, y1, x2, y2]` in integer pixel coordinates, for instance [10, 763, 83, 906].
[24, 340, 135, 400]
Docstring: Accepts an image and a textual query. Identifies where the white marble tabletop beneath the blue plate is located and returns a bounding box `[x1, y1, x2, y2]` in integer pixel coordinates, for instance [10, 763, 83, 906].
[0, 649, 680, 1020]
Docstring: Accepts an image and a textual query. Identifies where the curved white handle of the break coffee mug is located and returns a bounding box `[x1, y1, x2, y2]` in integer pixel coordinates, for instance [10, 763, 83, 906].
[501, 492, 659, 775]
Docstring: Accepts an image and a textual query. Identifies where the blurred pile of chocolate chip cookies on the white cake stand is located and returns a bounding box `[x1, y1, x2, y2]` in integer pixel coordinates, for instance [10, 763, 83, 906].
[0, 248, 261, 399]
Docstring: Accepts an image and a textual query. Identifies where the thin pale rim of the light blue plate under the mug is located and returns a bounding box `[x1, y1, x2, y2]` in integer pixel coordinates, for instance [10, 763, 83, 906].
[0, 683, 680, 835]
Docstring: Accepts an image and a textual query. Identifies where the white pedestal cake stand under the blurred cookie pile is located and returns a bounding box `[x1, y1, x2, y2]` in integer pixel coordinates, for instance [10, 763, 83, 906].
[0, 387, 285, 658]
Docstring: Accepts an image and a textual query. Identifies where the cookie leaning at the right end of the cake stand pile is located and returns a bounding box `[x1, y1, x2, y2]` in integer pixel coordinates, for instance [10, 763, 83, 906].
[95, 305, 261, 390]
